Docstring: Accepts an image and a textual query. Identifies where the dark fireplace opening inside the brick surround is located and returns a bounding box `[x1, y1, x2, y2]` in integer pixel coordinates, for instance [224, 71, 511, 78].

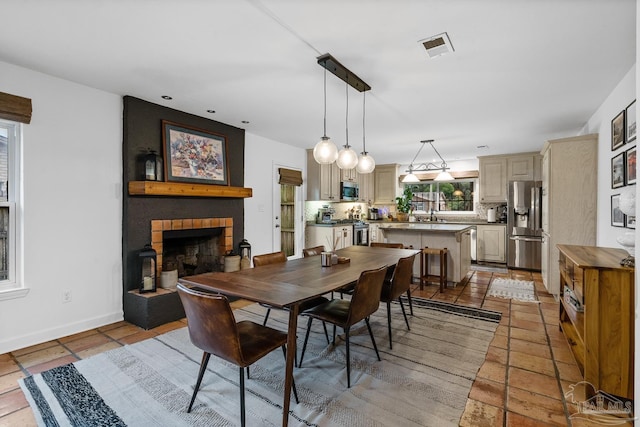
[162, 227, 225, 277]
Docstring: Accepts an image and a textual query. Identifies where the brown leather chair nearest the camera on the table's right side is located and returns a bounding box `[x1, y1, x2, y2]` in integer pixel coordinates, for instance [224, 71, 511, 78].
[298, 266, 387, 388]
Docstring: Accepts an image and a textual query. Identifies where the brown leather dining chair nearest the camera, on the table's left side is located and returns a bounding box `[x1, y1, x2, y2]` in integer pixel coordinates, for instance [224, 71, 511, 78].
[177, 283, 299, 426]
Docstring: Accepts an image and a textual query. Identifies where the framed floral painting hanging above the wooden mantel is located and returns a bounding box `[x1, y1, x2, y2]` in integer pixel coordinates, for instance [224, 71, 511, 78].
[162, 120, 229, 185]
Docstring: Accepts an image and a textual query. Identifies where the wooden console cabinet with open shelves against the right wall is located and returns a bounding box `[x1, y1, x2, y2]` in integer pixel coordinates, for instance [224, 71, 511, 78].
[557, 245, 635, 399]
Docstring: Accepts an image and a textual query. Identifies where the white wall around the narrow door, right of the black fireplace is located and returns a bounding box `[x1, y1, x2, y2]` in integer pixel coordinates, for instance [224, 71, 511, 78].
[244, 132, 312, 255]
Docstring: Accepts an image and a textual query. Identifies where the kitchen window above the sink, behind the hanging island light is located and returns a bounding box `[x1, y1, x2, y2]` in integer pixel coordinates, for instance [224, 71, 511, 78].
[405, 180, 476, 212]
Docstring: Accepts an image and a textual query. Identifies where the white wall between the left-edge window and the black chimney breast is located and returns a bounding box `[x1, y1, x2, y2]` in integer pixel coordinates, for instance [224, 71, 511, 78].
[0, 62, 122, 354]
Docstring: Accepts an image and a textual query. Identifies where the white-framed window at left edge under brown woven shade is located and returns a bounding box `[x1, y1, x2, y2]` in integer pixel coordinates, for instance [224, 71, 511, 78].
[0, 120, 22, 299]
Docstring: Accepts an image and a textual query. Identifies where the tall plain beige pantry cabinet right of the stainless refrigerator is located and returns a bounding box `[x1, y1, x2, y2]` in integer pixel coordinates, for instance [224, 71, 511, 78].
[542, 134, 598, 295]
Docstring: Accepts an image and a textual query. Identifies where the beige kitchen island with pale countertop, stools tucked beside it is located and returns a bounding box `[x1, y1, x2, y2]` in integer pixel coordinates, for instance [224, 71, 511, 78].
[378, 222, 475, 283]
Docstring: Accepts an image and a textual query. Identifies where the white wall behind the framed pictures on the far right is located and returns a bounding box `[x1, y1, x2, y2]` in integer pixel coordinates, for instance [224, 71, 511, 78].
[584, 65, 636, 248]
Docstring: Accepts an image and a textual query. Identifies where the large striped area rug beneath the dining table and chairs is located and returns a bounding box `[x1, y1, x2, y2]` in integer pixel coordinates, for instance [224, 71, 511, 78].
[20, 299, 500, 426]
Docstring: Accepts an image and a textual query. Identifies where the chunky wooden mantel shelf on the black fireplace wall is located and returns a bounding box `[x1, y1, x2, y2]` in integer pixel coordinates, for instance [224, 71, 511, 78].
[129, 181, 253, 198]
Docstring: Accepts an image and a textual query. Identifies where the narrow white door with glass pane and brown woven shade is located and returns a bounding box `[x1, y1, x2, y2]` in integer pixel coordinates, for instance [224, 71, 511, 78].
[272, 165, 304, 258]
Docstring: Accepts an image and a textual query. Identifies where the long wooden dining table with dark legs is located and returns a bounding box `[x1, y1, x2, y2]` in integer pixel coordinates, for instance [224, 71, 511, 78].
[179, 246, 419, 426]
